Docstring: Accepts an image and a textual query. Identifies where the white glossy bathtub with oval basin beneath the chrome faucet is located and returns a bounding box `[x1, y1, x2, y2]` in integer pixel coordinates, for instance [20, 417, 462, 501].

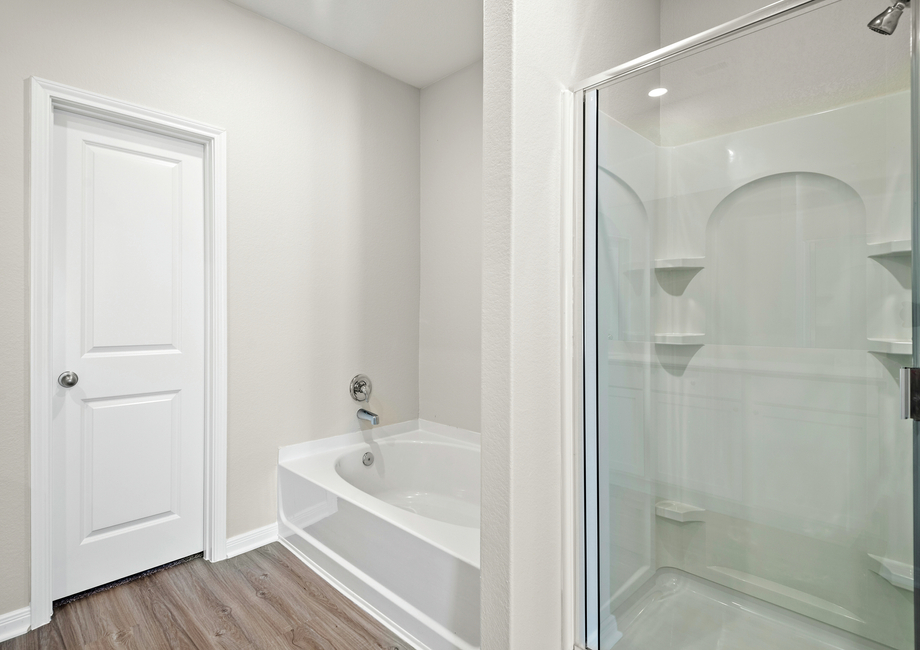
[278, 420, 480, 650]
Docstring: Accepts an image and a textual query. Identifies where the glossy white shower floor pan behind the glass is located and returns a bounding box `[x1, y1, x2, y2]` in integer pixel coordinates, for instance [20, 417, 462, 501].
[613, 569, 890, 650]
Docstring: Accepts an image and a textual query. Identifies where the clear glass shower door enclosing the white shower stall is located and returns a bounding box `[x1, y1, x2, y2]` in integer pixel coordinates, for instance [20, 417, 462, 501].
[584, 0, 920, 650]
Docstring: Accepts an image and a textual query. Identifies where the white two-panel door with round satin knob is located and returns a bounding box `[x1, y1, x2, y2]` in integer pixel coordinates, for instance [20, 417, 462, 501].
[52, 111, 205, 599]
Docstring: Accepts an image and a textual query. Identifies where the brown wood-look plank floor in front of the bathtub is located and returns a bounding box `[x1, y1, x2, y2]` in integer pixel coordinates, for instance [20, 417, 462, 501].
[0, 542, 412, 650]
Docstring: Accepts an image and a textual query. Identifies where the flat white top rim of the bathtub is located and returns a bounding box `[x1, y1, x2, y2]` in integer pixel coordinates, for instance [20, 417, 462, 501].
[279, 421, 480, 569]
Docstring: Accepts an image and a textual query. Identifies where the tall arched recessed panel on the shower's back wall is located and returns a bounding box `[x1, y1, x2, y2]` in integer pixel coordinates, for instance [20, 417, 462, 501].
[704, 172, 868, 349]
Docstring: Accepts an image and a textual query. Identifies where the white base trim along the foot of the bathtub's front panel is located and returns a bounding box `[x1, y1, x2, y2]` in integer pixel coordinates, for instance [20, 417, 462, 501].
[278, 514, 479, 650]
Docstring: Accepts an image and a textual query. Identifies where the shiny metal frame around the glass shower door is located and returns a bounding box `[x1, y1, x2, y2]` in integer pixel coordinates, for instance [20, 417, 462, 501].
[572, 0, 920, 650]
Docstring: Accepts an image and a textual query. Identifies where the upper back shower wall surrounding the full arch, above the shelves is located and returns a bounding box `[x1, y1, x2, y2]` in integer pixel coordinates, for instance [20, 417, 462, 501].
[654, 92, 910, 258]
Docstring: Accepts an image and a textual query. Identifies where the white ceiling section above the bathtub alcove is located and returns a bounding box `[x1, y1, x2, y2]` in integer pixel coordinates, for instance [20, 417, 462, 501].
[230, 0, 482, 88]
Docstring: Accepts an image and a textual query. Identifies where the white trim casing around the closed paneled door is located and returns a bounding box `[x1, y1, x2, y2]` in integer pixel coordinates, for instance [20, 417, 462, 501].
[28, 77, 227, 629]
